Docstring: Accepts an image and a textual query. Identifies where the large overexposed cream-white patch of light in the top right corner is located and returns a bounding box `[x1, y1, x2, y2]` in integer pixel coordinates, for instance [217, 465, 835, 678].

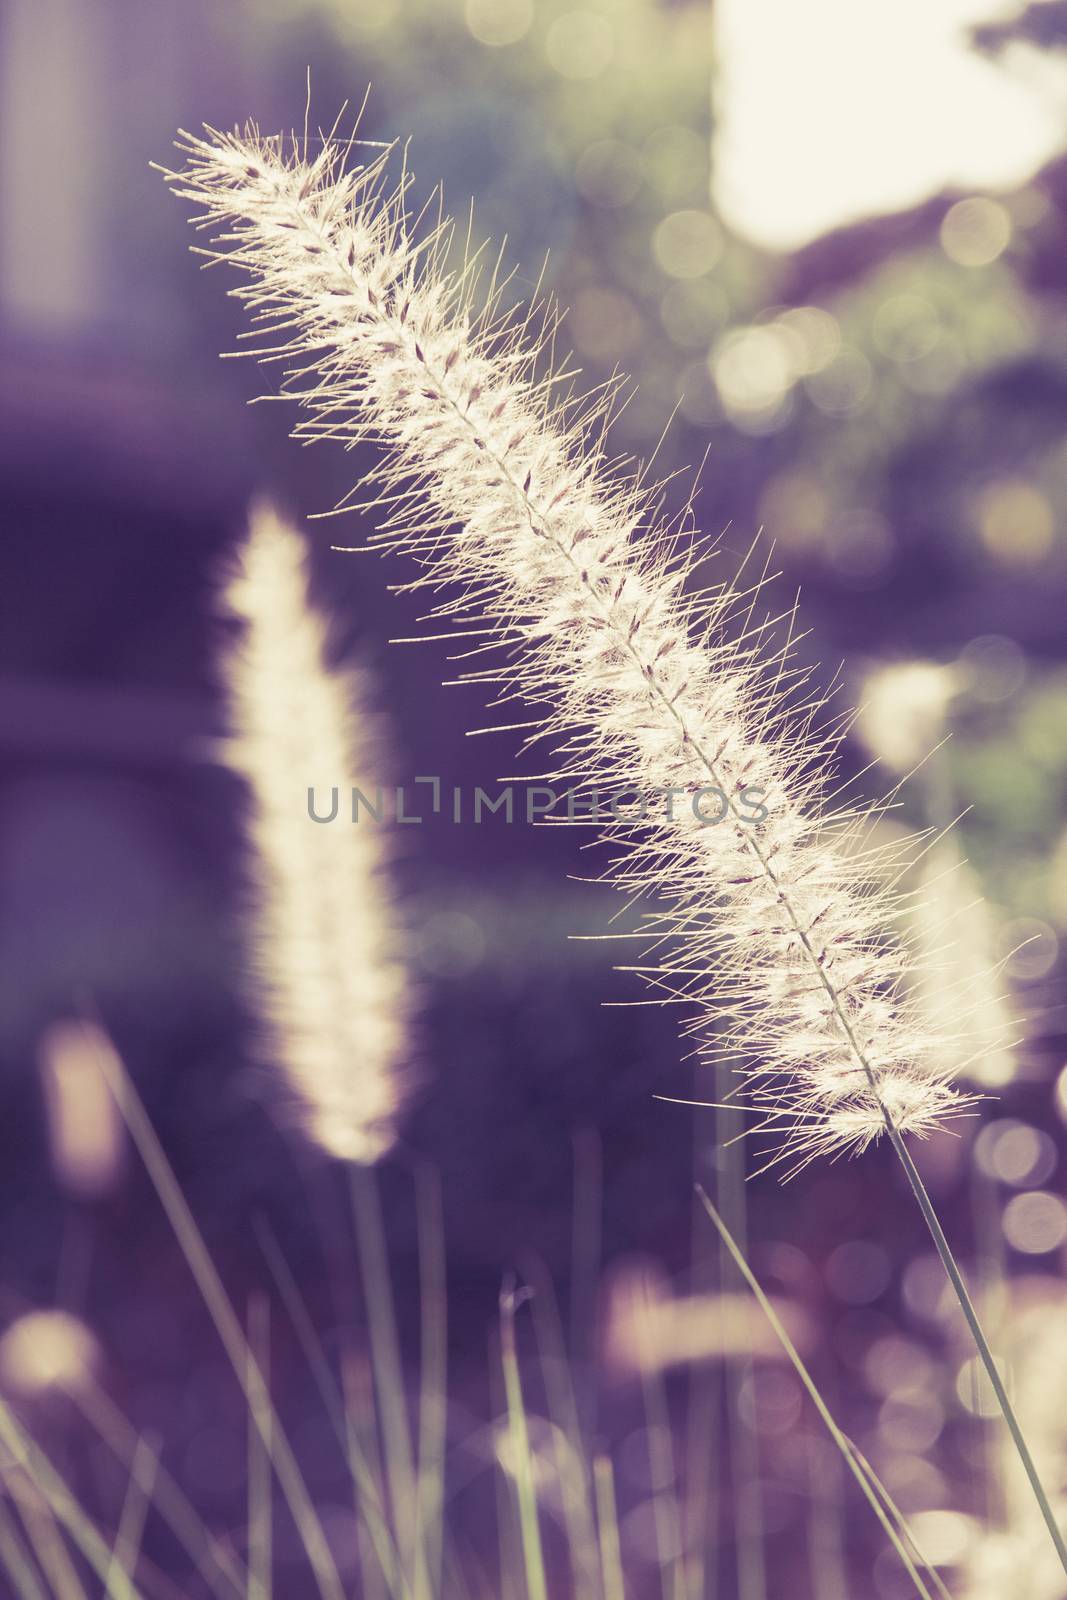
[713, 0, 1067, 250]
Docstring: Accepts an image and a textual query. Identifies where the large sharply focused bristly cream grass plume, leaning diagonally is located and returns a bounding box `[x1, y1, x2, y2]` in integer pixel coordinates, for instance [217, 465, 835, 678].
[168, 126, 960, 1168]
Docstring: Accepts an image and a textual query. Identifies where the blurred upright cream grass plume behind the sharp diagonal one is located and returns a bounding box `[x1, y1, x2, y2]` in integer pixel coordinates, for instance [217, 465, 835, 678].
[224, 506, 410, 1163]
